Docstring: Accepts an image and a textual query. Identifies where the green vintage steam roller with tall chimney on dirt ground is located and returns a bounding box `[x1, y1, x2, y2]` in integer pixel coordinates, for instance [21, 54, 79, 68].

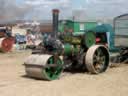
[24, 9, 109, 81]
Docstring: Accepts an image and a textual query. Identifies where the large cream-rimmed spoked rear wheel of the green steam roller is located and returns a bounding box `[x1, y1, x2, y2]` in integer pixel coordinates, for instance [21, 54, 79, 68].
[85, 45, 109, 74]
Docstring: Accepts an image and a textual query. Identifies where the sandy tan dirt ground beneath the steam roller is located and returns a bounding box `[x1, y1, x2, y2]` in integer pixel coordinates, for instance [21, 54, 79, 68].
[0, 51, 128, 96]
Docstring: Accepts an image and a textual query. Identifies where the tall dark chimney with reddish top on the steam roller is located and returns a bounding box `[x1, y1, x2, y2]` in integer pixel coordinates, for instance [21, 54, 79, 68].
[52, 9, 59, 38]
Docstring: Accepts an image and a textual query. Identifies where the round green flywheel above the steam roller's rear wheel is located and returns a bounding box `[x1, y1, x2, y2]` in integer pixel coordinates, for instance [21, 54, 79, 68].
[84, 31, 96, 48]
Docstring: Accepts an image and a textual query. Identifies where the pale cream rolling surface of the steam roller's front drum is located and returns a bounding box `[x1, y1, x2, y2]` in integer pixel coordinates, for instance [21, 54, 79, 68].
[24, 54, 63, 81]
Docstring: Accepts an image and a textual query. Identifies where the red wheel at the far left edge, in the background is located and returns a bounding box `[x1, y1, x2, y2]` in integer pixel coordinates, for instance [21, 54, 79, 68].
[1, 37, 14, 52]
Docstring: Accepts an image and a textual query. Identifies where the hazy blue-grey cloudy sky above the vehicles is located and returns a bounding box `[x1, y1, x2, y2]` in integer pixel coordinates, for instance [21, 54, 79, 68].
[0, 0, 128, 20]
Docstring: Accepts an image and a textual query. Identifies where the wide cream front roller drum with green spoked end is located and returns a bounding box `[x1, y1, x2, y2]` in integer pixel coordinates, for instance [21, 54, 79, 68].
[24, 54, 63, 80]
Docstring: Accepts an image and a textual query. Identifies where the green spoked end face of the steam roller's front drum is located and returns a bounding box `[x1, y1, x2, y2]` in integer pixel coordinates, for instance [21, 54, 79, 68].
[45, 56, 63, 80]
